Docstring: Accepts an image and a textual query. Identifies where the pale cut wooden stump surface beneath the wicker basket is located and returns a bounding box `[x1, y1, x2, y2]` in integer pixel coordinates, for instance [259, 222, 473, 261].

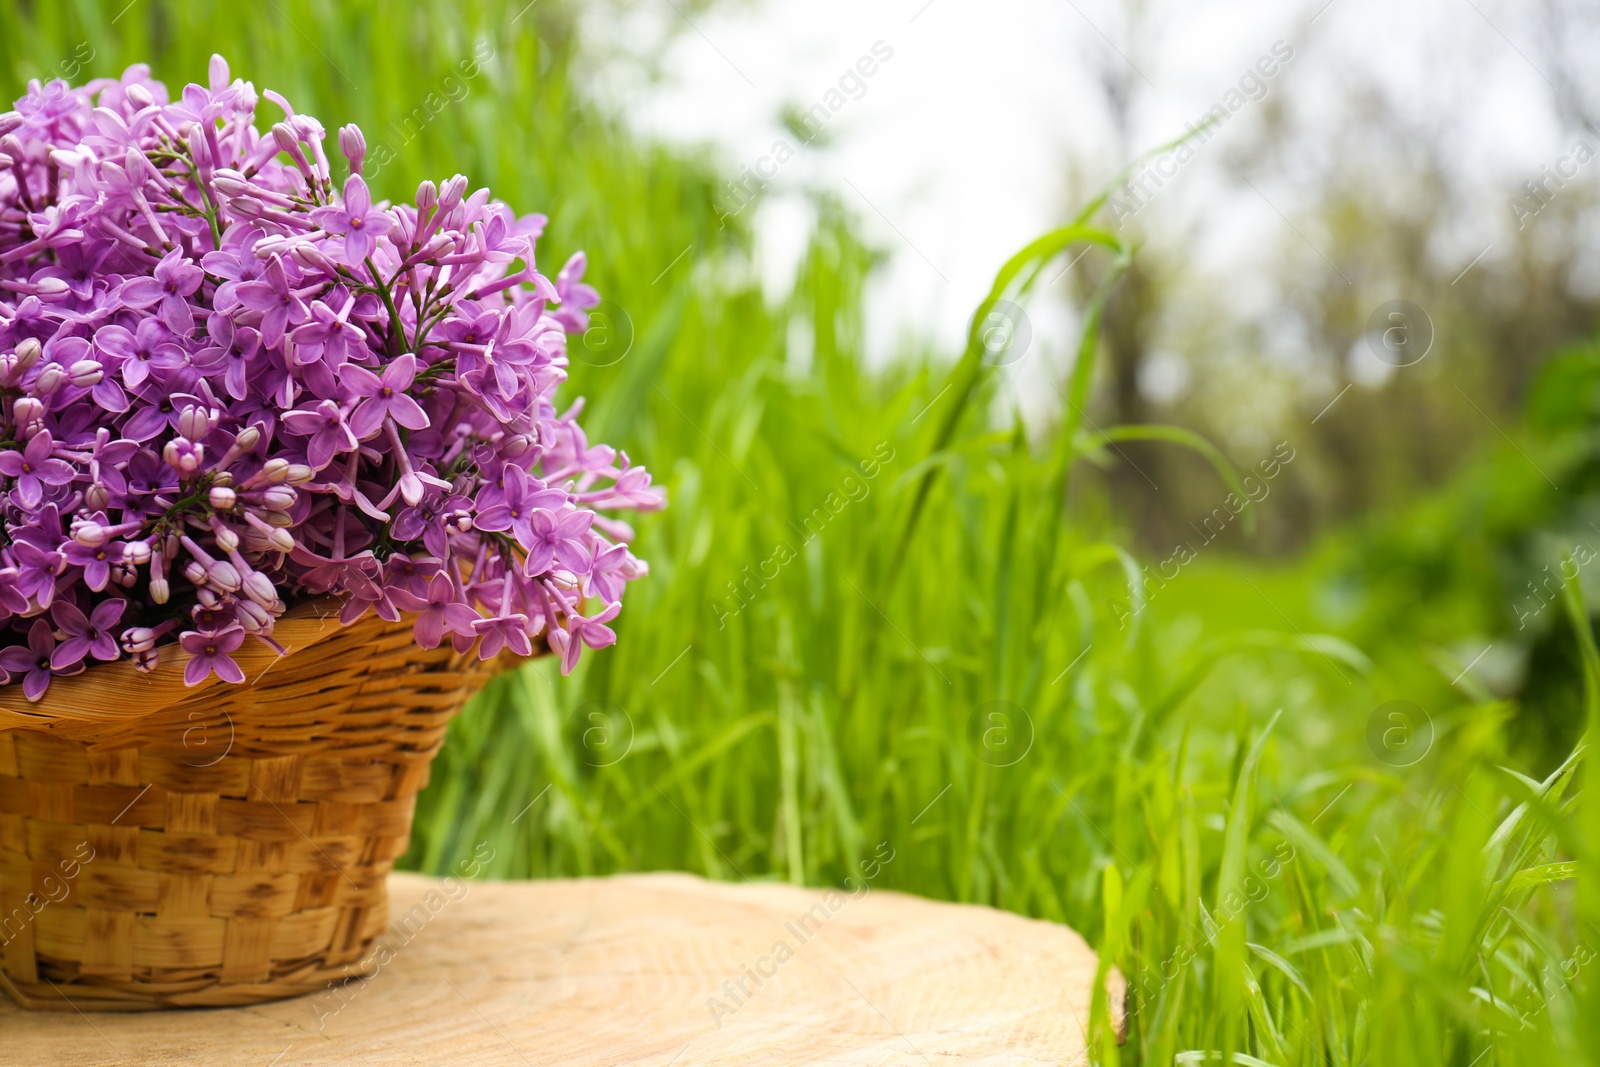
[0, 873, 1123, 1067]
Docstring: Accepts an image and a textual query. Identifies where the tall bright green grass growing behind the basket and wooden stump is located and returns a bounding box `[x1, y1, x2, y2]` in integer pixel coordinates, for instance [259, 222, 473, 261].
[0, 0, 1600, 1067]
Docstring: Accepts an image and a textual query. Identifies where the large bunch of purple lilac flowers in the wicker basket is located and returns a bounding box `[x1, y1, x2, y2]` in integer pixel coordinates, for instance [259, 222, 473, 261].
[0, 56, 662, 701]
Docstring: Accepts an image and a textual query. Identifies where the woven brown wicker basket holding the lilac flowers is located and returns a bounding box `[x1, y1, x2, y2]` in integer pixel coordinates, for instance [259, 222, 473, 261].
[0, 601, 508, 1011]
